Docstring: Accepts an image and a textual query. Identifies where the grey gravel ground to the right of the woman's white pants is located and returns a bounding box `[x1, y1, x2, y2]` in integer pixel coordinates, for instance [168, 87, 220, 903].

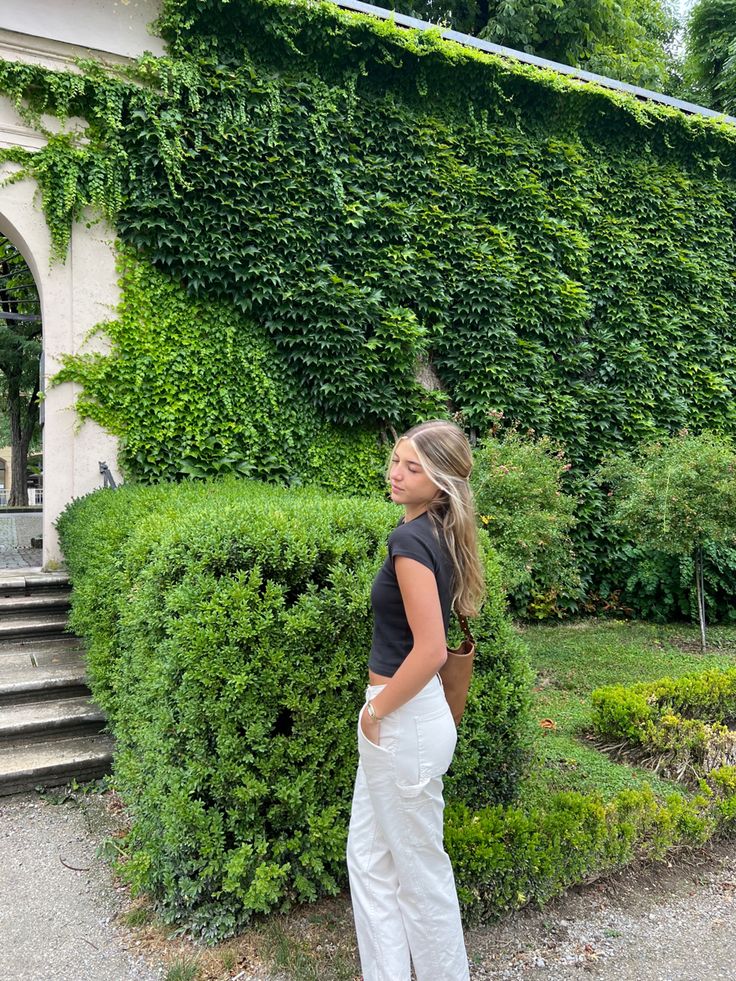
[468, 841, 736, 981]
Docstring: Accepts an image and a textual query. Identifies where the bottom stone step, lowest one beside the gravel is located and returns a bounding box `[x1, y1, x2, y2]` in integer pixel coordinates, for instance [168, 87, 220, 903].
[0, 734, 113, 797]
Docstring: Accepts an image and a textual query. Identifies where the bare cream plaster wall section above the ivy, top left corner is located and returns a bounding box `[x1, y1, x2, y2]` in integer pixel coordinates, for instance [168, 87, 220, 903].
[0, 0, 164, 58]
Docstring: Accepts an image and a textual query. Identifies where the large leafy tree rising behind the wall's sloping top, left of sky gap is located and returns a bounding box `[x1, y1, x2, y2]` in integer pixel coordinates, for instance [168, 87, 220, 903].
[395, 0, 680, 91]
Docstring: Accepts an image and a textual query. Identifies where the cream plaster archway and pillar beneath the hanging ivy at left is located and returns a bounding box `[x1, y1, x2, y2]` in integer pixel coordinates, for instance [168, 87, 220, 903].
[0, 97, 119, 568]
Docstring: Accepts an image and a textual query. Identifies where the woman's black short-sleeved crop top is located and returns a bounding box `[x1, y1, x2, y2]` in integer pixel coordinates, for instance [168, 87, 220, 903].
[368, 511, 453, 678]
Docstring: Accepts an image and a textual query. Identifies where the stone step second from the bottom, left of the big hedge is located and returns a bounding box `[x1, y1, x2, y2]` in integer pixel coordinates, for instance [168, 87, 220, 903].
[0, 696, 106, 745]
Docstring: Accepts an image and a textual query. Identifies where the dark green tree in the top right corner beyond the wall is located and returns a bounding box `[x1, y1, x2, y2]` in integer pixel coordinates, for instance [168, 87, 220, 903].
[684, 0, 736, 113]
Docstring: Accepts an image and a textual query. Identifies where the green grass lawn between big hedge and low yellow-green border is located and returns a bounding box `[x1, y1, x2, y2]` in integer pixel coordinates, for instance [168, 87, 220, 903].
[519, 620, 736, 805]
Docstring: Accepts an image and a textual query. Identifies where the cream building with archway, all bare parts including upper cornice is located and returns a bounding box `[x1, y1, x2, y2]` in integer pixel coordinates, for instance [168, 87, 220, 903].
[0, 0, 163, 568]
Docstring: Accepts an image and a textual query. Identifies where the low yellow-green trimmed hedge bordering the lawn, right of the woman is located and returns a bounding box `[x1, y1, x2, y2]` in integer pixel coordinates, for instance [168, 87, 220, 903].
[454, 669, 736, 921]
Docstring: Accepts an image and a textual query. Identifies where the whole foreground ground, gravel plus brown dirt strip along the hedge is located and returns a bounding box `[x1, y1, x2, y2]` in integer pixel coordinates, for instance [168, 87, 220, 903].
[0, 792, 736, 981]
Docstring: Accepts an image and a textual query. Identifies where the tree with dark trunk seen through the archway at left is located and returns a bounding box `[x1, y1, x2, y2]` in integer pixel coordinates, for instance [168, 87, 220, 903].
[0, 238, 41, 507]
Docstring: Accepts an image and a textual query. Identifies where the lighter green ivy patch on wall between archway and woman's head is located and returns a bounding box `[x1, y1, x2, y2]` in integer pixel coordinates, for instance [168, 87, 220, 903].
[57, 249, 387, 493]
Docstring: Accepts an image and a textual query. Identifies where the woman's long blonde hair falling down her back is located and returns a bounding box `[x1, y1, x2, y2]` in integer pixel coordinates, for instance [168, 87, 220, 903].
[394, 419, 485, 616]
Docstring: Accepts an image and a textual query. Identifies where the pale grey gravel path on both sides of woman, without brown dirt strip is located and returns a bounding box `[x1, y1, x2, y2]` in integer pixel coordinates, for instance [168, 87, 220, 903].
[0, 792, 736, 981]
